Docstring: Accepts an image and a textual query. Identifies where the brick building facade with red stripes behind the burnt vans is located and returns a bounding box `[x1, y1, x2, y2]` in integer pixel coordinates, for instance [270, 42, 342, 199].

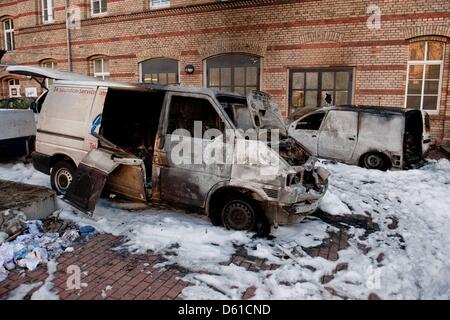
[0, 0, 450, 142]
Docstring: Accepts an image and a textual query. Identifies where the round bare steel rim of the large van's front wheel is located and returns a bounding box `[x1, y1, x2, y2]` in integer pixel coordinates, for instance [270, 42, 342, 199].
[222, 200, 255, 230]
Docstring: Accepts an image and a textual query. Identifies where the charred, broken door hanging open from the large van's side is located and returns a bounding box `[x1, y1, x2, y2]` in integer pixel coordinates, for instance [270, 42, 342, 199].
[64, 149, 146, 214]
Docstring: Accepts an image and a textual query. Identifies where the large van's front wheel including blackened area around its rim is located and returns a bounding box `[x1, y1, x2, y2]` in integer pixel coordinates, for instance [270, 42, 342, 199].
[221, 196, 270, 234]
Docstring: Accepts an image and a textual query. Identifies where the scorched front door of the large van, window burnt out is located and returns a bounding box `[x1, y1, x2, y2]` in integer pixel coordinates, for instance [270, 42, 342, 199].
[153, 93, 233, 207]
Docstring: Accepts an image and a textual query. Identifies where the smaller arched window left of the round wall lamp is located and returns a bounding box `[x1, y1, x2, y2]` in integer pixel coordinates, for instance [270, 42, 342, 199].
[141, 58, 178, 85]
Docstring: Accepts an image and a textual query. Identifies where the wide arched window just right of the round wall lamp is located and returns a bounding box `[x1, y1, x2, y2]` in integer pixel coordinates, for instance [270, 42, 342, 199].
[206, 53, 260, 95]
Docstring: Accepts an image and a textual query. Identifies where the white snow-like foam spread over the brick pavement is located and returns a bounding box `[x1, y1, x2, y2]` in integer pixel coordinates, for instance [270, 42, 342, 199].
[0, 160, 450, 299]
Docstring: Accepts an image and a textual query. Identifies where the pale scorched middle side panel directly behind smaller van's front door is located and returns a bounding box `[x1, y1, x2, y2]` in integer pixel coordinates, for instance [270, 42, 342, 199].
[318, 110, 358, 161]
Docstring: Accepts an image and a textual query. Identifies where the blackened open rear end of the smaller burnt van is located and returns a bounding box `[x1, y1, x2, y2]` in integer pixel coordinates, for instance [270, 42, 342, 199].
[403, 110, 423, 166]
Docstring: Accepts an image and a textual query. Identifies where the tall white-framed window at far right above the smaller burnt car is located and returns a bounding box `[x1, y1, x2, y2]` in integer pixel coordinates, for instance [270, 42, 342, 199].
[405, 41, 445, 111]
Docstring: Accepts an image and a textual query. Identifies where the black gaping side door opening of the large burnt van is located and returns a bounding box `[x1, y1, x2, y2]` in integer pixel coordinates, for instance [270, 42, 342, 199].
[100, 89, 165, 179]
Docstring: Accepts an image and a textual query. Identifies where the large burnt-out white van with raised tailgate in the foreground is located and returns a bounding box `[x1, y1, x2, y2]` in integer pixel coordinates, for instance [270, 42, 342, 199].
[7, 66, 329, 235]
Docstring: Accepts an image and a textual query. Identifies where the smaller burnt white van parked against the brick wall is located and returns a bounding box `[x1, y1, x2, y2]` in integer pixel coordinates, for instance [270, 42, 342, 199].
[288, 106, 431, 170]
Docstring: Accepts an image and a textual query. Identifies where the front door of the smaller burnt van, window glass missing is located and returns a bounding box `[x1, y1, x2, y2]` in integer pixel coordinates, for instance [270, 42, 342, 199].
[289, 111, 325, 156]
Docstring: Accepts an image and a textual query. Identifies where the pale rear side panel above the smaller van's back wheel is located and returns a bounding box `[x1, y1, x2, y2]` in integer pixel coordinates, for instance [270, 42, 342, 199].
[352, 112, 405, 164]
